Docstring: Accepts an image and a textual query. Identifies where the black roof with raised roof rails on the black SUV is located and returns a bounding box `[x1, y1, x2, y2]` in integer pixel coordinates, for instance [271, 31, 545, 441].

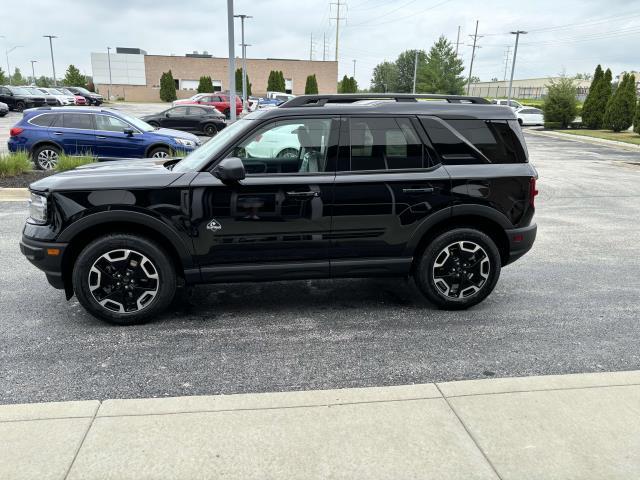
[250, 93, 516, 120]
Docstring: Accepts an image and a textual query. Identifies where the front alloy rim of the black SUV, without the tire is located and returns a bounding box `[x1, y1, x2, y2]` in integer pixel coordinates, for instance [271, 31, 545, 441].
[88, 249, 160, 313]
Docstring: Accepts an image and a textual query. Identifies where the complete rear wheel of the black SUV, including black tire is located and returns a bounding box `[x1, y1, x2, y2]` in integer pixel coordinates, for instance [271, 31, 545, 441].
[414, 228, 501, 310]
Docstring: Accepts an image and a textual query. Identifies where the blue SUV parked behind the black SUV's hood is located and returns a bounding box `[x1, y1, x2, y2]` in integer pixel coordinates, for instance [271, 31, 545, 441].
[8, 107, 200, 170]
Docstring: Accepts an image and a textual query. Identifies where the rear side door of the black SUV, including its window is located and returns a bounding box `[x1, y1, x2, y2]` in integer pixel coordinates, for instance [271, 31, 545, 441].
[330, 116, 451, 276]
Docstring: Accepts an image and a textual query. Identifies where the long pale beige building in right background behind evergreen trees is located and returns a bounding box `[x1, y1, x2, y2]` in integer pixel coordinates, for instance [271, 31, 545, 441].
[469, 77, 591, 99]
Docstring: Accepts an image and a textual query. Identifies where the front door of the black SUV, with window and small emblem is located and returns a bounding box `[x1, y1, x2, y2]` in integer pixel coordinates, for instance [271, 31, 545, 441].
[191, 117, 338, 281]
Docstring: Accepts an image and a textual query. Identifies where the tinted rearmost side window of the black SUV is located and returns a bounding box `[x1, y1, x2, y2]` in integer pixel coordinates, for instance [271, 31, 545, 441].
[448, 120, 527, 163]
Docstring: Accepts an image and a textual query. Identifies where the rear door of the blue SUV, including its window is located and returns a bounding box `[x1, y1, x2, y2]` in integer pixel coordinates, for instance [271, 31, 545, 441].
[49, 112, 96, 155]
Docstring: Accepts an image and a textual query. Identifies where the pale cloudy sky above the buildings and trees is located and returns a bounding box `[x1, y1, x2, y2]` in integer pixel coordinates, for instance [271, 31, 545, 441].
[0, 0, 640, 87]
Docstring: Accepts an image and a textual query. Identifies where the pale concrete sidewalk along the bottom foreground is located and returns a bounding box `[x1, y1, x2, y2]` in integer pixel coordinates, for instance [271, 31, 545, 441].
[0, 371, 640, 480]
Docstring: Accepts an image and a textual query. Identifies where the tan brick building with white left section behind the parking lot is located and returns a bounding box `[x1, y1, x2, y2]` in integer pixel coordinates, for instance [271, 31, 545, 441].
[91, 48, 338, 102]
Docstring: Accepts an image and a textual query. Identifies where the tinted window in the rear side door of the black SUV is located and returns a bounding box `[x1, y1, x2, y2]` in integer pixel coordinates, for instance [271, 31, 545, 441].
[349, 118, 426, 171]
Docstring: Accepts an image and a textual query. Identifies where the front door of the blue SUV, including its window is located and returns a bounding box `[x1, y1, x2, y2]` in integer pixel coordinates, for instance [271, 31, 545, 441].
[95, 113, 146, 158]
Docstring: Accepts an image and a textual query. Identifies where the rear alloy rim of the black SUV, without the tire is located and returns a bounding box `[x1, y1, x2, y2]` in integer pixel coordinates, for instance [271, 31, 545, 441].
[431, 240, 491, 299]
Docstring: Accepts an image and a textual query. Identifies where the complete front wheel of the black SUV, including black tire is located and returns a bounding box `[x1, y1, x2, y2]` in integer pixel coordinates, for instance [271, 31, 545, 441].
[73, 233, 176, 325]
